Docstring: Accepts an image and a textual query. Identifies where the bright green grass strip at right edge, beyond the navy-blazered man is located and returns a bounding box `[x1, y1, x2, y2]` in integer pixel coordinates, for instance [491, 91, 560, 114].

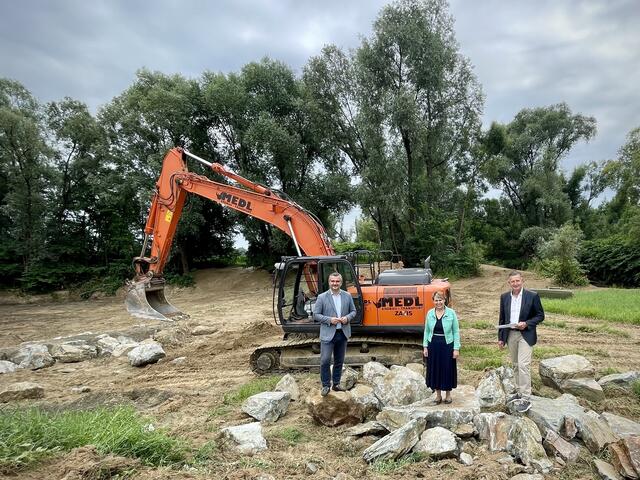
[542, 288, 640, 325]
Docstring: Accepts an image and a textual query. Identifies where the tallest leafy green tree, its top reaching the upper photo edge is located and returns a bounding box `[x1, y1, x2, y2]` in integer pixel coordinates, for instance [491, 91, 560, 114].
[304, 0, 483, 270]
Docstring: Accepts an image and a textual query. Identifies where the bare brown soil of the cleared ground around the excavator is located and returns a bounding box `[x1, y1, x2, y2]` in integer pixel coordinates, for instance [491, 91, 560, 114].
[0, 266, 640, 480]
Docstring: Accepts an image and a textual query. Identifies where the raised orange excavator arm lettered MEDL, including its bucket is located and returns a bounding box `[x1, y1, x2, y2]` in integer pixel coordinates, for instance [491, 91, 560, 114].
[125, 148, 334, 320]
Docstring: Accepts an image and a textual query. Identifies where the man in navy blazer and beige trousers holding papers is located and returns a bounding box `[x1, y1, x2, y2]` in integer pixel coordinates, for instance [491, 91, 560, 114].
[498, 271, 544, 413]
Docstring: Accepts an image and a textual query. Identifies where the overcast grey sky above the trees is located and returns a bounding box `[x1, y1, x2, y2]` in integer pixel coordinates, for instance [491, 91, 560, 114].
[0, 0, 640, 238]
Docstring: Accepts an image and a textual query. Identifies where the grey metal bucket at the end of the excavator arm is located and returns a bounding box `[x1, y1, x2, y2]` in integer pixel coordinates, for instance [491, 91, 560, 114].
[124, 279, 189, 321]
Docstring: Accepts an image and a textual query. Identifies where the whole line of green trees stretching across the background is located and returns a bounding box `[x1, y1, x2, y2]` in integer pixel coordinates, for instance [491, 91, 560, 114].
[0, 0, 640, 292]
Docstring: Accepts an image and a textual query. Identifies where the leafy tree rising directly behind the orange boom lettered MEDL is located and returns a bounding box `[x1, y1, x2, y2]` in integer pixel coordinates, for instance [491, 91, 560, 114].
[202, 58, 352, 266]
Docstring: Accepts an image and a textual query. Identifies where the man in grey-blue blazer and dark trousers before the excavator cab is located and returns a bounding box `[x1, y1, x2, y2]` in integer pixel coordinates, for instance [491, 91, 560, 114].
[313, 272, 356, 397]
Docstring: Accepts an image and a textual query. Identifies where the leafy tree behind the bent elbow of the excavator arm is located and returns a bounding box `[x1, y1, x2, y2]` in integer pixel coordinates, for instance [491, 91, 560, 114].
[99, 70, 233, 273]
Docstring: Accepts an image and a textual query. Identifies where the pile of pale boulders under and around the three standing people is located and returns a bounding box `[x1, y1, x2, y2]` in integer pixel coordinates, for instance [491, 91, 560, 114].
[221, 359, 640, 479]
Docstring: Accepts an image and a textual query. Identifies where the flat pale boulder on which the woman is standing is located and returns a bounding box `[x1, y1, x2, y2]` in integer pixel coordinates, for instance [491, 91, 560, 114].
[376, 385, 480, 431]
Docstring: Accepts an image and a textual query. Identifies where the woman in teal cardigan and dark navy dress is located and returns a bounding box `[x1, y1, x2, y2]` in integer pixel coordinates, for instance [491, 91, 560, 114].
[422, 292, 460, 405]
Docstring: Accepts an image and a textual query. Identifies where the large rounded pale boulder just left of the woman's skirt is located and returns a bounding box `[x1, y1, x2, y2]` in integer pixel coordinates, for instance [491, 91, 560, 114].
[373, 365, 431, 406]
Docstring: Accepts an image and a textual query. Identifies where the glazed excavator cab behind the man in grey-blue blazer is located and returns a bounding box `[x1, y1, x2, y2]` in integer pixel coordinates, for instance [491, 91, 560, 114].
[274, 257, 363, 333]
